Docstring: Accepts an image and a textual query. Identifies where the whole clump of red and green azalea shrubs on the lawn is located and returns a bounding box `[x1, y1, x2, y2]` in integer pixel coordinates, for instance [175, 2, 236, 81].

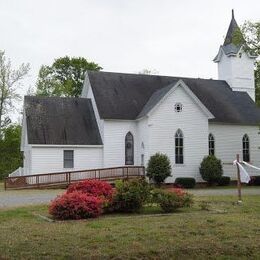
[49, 179, 193, 220]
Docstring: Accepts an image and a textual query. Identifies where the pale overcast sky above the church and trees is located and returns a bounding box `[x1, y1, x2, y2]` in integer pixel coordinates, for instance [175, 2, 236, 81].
[0, 0, 260, 120]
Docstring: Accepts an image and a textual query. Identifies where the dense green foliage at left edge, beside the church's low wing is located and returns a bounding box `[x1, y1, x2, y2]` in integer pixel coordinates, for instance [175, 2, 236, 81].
[0, 124, 22, 179]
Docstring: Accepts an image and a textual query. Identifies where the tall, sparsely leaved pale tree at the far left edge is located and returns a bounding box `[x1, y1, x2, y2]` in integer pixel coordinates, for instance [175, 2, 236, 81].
[0, 50, 30, 139]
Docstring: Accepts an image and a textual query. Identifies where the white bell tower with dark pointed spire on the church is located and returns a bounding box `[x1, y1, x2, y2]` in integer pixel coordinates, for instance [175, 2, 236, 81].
[213, 10, 257, 101]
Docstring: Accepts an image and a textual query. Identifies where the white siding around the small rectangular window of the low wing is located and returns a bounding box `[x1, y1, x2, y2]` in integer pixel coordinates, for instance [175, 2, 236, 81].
[30, 147, 103, 174]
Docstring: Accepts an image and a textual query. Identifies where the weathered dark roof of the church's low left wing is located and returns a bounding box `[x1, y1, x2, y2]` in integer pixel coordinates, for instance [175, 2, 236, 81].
[24, 96, 102, 145]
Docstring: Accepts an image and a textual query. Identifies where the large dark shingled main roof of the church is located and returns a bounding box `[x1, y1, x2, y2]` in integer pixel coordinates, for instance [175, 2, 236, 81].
[87, 71, 260, 125]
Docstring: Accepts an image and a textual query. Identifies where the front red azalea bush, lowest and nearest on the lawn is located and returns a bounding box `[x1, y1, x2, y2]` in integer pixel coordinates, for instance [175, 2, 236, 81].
[49, 191, 103, 220]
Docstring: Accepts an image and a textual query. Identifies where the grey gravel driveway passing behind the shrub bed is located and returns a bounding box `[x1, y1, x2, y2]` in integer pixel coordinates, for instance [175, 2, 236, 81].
[0, 184, 260, 209]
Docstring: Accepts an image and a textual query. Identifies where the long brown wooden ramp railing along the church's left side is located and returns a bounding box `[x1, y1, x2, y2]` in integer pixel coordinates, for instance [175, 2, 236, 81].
[4, 166, 145, 189]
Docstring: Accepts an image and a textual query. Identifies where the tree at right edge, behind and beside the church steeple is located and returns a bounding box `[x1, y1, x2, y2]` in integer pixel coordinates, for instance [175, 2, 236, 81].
[234, 21, 260, 106]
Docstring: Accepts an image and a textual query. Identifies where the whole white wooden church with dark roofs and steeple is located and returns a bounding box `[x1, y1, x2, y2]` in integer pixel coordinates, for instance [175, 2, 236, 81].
[21, 11, 260, 183]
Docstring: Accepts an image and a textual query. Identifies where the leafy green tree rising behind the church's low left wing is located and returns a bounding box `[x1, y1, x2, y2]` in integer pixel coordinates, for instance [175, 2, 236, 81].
[36, 56, 102, 97]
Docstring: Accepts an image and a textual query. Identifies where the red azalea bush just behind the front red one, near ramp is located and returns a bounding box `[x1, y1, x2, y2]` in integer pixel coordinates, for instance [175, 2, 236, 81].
[67, 180, 113, 202]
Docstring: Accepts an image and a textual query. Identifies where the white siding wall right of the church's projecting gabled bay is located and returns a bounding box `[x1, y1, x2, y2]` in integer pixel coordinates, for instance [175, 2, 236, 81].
[209, 123, 260, 179]
